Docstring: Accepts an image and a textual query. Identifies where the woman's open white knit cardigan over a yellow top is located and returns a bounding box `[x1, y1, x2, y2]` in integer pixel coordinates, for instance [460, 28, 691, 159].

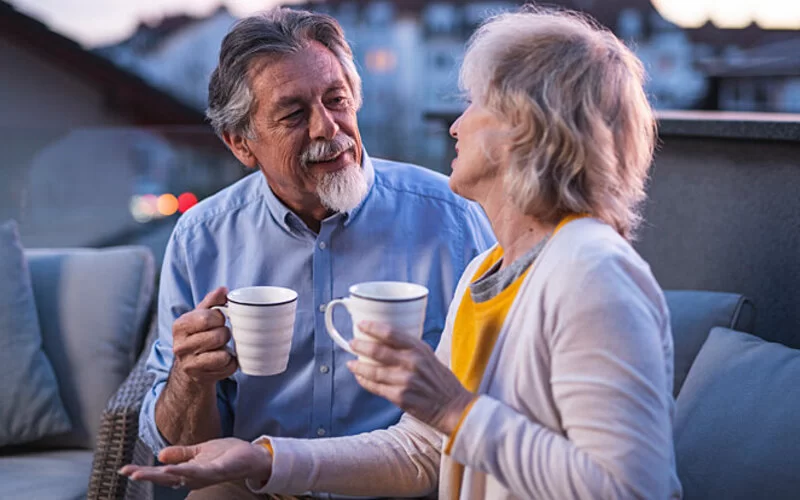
[253, 219, 681, 500]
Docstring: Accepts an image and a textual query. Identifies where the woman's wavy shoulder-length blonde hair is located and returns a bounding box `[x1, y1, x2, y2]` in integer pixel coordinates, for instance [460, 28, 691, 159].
[461, 6, 656, 239]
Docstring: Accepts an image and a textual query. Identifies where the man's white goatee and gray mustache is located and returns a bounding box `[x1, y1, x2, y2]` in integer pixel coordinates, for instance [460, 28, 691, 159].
[300, 132, 368, 212]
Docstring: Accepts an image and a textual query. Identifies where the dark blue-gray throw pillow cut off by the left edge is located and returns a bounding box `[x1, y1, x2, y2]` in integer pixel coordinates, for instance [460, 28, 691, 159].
[0, 221, 71, 446]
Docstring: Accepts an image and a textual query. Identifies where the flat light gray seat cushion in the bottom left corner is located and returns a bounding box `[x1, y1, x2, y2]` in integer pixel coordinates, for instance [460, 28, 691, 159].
[0, 450, 92, 500]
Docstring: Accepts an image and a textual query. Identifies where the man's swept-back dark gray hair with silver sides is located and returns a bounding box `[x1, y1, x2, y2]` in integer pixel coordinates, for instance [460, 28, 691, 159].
[206, 7, 361, 137]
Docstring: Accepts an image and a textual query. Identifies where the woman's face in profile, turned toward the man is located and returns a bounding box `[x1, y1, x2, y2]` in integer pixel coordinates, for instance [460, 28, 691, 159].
[450, 101, 508, 203]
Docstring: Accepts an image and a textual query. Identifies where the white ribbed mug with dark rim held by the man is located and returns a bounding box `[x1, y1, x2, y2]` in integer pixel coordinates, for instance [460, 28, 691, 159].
[212, 286, 297, 375]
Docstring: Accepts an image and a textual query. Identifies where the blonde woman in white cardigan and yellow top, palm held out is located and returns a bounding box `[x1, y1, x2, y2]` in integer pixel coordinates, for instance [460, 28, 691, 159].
[122, 10, 681, 500]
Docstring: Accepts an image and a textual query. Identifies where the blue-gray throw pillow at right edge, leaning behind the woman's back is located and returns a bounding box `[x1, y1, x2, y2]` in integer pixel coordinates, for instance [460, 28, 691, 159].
[675, 328, 800, 500]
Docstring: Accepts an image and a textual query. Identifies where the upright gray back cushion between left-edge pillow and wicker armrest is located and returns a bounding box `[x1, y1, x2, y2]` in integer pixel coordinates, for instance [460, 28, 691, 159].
[27, 247, 155, 448]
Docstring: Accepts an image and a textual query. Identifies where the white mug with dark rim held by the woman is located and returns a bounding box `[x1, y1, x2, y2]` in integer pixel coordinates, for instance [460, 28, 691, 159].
[325, 281, 428, 361]
